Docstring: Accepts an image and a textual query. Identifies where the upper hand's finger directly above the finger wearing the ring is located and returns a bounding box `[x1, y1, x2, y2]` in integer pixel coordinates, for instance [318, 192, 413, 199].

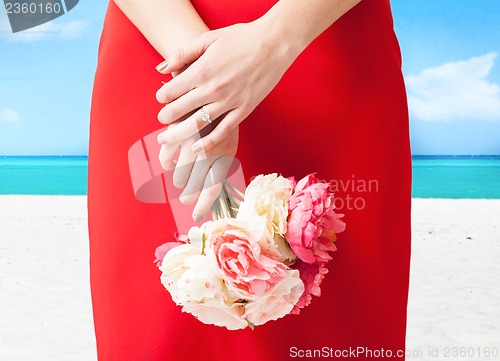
[158, 88, 210, 124]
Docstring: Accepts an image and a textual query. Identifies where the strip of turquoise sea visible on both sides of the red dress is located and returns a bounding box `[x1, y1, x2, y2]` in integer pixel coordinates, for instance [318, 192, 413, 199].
[0, 156, 500, 199]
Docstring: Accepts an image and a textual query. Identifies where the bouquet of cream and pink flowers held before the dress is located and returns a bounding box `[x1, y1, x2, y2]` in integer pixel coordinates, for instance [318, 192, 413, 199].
[155, 174, 345, 330]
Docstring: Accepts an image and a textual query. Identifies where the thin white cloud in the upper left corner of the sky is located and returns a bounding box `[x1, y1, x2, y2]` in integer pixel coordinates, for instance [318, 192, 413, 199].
[0, 16, 88, 43]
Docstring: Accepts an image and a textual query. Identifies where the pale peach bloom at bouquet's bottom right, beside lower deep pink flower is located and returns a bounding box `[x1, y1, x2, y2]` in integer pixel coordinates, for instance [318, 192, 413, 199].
[243, 270, 304, 326]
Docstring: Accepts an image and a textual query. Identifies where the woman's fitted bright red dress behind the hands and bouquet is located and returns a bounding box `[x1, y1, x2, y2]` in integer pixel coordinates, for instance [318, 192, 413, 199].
[88, 0, 411, 361]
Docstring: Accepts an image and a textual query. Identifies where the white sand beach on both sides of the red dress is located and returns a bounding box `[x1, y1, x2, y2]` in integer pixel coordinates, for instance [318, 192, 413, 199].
[0, 196, 500, 361]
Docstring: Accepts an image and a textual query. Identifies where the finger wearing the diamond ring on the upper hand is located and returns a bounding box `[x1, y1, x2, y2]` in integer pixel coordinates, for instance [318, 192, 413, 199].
[158, 103, 222, 144]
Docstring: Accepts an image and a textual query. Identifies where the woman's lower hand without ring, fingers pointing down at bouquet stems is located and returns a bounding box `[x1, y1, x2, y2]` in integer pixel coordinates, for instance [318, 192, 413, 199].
[159, 121, 238, 222]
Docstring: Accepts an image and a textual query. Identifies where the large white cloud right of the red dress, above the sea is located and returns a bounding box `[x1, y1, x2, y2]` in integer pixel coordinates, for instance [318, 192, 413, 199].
[406, 53, 500, 121]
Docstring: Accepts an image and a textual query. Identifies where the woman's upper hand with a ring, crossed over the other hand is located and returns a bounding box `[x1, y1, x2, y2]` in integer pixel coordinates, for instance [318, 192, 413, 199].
[156, 19, 300, 154]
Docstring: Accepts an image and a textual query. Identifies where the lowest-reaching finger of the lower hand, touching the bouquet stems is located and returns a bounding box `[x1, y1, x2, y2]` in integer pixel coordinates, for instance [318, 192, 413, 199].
[193, 156, 234, 222]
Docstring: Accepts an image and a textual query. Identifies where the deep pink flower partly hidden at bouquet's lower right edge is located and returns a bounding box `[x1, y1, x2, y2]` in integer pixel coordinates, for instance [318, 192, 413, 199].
[291, 260, 328, 315]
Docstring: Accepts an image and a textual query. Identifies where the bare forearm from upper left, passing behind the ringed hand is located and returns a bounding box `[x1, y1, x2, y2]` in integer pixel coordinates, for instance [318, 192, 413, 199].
[114, 0, 208, 58]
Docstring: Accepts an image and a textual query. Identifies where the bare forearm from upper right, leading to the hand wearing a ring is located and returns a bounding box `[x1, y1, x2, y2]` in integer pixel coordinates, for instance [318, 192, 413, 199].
[259, 0, 361, 55]
